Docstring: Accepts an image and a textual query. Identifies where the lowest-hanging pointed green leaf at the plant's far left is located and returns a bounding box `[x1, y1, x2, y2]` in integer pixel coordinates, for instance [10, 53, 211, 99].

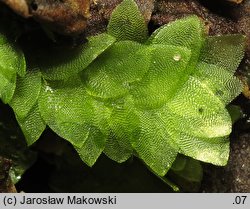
[16, 103, 46, 145]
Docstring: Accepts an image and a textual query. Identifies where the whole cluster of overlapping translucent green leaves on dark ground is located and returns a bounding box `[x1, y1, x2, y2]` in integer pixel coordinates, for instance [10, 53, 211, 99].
[0, 0, 245, 180]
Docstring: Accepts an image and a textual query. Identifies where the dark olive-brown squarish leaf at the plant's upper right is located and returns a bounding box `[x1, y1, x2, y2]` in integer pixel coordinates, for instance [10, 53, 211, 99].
[200, 34, 245, 73]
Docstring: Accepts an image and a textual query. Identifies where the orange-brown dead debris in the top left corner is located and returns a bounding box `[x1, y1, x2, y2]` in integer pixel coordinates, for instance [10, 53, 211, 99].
[0, 0, 90, 35]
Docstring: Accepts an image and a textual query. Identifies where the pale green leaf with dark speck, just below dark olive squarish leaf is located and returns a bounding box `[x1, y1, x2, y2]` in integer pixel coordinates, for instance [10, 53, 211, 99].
[195, 62, 243, 105]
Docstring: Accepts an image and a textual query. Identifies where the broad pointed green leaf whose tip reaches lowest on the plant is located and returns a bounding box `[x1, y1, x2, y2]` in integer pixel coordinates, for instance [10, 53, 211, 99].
[131, 112, 178, 176]
